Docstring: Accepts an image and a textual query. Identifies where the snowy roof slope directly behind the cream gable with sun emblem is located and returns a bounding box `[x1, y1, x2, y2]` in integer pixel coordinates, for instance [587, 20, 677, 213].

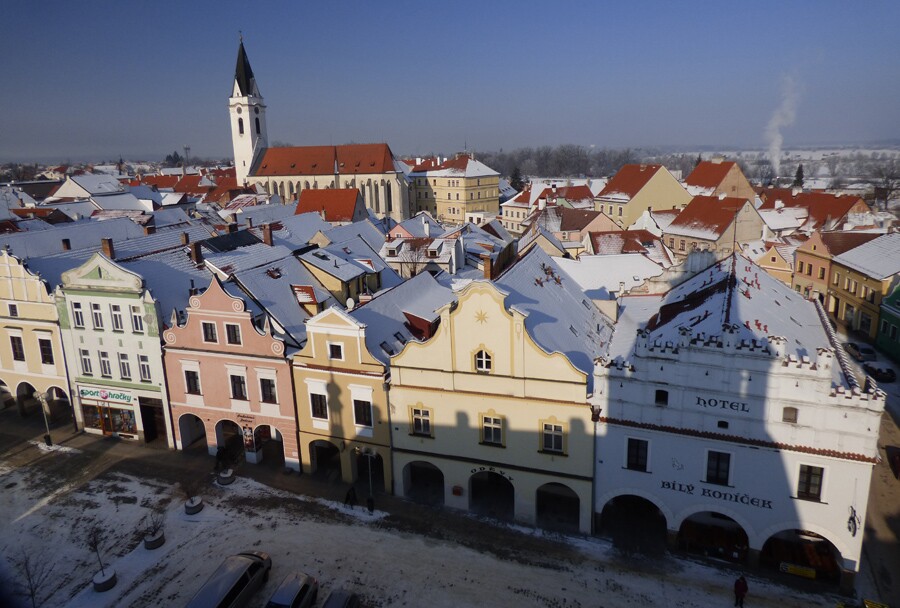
[495, 247, 613, 393]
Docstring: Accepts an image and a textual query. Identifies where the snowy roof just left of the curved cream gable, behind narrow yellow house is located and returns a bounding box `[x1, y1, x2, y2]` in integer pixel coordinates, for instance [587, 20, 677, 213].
[348, 272, 456, 365]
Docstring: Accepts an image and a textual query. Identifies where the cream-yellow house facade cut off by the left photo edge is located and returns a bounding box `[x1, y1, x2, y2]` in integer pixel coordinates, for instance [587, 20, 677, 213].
[0, 250, 71, 418]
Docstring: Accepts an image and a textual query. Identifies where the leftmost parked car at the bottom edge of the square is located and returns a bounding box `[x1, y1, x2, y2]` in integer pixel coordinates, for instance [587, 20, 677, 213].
[187, 551, 272, 608]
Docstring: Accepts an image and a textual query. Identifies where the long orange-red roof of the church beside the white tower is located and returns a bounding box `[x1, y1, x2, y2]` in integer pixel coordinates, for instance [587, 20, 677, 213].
[251, 144, 396, 177]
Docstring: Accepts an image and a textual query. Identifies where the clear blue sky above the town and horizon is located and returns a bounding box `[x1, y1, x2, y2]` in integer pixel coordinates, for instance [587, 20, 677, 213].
[0, 0, 900, 162]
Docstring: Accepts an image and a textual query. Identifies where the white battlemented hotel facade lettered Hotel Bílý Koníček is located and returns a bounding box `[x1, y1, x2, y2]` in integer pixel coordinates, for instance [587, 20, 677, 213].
[592, 262, 885, 588]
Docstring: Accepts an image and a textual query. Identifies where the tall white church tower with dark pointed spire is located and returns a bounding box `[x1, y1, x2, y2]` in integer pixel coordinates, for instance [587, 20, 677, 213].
[228, 38, 269, 185]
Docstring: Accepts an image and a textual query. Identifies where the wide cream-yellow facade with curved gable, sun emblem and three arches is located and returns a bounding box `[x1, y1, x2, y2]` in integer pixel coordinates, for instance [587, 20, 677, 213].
[390, 278, 593, 532]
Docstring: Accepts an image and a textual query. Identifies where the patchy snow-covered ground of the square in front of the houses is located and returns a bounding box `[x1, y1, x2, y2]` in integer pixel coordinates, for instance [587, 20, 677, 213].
[0, 452, 852, 608]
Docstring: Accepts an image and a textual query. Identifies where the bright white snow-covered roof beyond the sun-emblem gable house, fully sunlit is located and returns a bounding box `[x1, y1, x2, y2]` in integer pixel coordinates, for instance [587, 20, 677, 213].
[556, 253, 663, 300]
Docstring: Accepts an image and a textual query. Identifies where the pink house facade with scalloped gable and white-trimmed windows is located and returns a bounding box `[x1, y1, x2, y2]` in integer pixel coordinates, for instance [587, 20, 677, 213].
[163, 277, 300, 471]
